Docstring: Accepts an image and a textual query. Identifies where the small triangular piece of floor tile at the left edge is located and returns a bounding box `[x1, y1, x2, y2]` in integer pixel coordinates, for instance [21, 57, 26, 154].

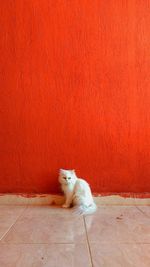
[0, 205, 26, 240]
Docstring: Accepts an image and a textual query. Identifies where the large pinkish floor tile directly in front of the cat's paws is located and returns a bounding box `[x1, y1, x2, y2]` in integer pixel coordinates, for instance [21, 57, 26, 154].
[2, 207, 86, 243]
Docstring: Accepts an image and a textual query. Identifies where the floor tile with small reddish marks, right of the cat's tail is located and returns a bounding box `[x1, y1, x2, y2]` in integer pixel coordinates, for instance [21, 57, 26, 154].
[85, 206, 150, 245]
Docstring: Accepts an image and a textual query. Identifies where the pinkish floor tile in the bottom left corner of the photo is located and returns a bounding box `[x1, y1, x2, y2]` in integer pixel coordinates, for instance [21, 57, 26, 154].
[0, 244, 91, 267]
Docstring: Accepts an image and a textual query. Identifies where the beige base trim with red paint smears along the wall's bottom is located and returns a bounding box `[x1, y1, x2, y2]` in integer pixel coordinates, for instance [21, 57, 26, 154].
[0, 193, 150, 206]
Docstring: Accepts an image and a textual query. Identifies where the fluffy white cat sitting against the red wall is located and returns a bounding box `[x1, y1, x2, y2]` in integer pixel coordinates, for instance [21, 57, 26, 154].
[59, 169, 97, 214]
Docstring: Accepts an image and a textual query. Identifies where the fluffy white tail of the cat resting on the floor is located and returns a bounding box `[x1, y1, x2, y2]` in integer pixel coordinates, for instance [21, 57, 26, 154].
[73, 202, 97, 215]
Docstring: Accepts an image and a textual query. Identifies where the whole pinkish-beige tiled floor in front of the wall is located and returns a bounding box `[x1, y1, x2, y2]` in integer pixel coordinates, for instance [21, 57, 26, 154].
[0, 205, 150, 267]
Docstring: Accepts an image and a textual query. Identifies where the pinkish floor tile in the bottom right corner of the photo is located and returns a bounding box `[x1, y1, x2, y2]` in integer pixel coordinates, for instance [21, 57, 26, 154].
[91, 243, 150, 267]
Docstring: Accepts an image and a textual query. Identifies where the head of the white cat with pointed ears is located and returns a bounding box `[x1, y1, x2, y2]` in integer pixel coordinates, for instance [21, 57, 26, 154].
[59, 169, 77, 185]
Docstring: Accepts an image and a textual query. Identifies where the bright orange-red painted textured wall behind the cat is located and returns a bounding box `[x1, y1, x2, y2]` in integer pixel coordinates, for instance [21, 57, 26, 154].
[0, 0, 150, 193]
